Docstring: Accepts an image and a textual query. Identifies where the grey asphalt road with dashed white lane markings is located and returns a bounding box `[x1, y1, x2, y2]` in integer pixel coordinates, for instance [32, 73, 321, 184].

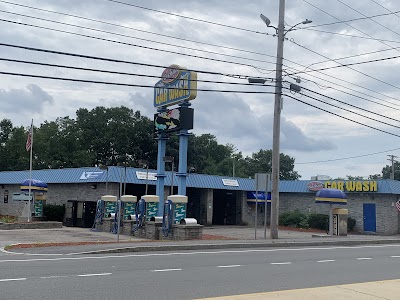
[0, 245, 400, 300]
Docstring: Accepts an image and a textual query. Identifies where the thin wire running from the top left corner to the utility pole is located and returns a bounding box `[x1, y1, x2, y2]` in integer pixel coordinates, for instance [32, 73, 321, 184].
[0, 0, 276, 58]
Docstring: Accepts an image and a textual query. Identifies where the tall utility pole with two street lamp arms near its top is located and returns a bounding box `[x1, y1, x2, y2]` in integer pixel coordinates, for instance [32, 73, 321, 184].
[253, 5, 312, 239]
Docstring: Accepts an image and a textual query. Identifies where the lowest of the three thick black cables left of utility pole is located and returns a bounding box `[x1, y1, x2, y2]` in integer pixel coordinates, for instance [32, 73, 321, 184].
[0, 71, 275, 94]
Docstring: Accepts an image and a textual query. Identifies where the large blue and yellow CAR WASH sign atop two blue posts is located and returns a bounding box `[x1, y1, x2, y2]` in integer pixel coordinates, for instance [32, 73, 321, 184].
[154, 65, 197, 107]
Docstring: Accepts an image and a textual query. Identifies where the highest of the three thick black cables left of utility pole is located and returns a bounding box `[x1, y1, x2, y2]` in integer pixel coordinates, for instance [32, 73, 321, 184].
[0, 43, 272, 80]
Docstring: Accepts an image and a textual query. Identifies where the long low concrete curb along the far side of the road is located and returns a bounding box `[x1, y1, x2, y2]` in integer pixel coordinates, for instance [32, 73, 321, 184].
[67, 239, 400, 255]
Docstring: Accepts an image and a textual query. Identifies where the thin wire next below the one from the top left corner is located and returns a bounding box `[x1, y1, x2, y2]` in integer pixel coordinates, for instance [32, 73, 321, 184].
[0, 9, 275, 67]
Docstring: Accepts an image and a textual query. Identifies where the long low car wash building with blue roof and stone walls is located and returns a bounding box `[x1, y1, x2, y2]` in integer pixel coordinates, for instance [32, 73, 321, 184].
[0, 166, 400, 235]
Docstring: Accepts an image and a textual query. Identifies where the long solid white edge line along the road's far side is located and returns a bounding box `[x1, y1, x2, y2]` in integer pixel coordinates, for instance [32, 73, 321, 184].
[0, 245, 400, 263]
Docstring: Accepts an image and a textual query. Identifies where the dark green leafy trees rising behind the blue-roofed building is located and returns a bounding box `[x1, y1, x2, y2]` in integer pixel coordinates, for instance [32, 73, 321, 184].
[0, 106, 300, 180]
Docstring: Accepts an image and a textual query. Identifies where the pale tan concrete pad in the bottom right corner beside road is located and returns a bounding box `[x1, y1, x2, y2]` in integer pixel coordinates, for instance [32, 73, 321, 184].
[197, 279, 400, 300]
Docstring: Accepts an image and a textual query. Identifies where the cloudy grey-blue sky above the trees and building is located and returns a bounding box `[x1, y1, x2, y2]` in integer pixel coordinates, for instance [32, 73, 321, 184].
[0, 0, 400, 179]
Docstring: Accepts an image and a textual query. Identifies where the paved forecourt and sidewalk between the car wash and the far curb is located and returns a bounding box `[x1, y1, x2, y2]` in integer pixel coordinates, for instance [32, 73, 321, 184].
[0, 226, 400, 255]
